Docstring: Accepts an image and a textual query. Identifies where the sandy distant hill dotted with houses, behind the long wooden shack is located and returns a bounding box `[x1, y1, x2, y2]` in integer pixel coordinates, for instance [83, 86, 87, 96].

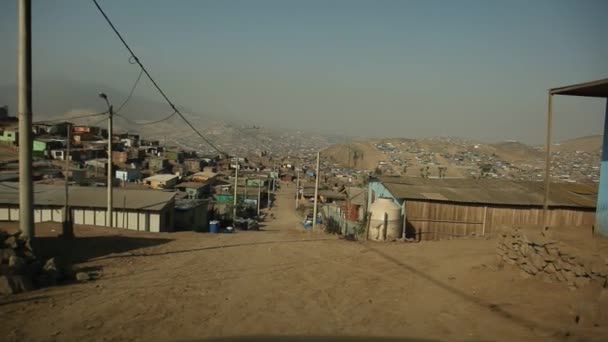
[322, 136, 601, 182]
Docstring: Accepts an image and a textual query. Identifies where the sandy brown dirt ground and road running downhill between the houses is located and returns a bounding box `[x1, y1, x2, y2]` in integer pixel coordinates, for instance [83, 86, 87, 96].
[0, 187, 608, 341]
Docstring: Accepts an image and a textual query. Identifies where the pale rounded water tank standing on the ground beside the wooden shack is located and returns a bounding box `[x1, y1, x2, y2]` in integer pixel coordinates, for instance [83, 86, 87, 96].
[368, 197, 403, 241]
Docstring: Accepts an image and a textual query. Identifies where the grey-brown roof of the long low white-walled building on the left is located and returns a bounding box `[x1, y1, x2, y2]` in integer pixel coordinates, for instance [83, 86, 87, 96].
[0, 182, 175, 211]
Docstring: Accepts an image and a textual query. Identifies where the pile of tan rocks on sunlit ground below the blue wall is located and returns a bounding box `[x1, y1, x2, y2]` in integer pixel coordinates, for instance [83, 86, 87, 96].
[498, 228, 608, 288]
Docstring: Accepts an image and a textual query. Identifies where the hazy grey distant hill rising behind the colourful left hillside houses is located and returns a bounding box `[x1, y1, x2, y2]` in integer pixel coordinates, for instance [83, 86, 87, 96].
[0, 80, 344, 154]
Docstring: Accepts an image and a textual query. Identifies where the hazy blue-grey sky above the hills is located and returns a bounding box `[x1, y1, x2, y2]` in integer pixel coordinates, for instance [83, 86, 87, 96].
[0, 0, 608, 143]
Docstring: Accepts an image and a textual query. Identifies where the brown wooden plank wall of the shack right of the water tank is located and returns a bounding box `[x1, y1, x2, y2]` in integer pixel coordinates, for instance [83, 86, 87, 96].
[406, 201, 595, 240]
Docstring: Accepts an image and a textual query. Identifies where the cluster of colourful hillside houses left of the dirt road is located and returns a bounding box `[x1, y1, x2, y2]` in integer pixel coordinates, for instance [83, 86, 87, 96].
[0, 122, 280, 231]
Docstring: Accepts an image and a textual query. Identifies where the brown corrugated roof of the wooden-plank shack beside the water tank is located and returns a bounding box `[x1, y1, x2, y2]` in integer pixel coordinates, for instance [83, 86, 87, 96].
[378, 177, 597, 208]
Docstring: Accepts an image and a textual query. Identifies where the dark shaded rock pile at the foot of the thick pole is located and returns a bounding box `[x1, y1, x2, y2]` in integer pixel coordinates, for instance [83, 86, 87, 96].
[0, 231, 89, 295]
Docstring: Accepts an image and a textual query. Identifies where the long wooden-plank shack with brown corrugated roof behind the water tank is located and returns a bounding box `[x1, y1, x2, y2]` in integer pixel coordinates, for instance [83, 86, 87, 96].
[367, 177, 597, 240]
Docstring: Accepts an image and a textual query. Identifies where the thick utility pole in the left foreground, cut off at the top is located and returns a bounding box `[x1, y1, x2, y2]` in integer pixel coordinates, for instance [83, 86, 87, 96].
[17, 0, 35, 239]
